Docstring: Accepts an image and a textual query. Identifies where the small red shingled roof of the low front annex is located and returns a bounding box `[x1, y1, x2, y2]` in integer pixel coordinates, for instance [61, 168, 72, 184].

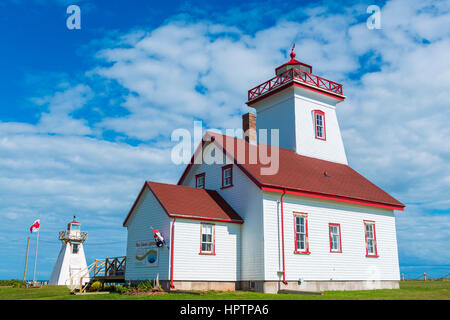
[123, 181, 244, 226]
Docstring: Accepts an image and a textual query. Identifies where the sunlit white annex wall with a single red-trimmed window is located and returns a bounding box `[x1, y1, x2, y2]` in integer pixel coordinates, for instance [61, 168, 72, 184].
[174, 218, 241, 281]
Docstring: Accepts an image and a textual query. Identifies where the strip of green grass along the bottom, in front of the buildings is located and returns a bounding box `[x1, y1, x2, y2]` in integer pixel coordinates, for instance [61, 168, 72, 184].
[0, 280, 450, 300]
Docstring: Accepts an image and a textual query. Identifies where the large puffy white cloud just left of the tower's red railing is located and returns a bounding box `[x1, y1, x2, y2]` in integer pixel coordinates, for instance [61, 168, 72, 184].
[91, 21, 304, 140]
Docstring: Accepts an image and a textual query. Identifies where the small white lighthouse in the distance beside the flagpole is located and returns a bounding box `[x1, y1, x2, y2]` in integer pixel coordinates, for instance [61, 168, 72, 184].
[49, 217, 89, 285]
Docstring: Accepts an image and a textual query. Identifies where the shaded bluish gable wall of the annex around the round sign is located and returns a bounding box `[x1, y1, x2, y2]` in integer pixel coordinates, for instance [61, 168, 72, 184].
[125, 187, 171, 280]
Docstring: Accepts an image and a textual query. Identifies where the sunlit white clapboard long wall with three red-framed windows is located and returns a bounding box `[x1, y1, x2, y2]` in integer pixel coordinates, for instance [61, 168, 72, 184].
[264, 192, 400, 281]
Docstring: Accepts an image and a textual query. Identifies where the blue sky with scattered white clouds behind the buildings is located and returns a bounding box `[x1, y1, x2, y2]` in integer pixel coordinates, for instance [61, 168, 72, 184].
[0, 0, 450, 279]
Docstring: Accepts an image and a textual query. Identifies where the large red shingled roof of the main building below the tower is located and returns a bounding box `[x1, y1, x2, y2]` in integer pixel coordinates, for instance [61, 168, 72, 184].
[178, 132, 405, 210]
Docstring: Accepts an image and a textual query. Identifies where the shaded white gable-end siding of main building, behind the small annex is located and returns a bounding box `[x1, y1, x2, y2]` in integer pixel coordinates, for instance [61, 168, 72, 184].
[183, 142, 264, 280]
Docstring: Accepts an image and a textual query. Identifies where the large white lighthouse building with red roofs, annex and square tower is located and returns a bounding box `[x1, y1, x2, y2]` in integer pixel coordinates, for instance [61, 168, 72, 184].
[123, 52, 404, 293]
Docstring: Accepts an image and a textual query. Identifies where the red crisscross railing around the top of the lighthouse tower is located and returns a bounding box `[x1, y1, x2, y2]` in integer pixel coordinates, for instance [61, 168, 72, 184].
[248, 69, 342, 101]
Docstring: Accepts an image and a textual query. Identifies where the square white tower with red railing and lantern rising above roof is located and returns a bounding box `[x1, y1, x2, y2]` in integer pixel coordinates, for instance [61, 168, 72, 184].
[247, 51, 347, 164]
